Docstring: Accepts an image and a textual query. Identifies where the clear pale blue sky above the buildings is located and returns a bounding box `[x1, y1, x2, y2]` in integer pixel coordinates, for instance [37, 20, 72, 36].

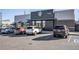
[0, 9, 79, 22]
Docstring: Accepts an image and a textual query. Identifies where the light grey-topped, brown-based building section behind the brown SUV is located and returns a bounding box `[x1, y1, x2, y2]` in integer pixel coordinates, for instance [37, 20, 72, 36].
[54, 9, 75, 31]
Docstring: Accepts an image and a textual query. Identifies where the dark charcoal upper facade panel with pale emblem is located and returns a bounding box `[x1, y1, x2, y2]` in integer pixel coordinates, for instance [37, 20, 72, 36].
[31, 9, 54, 20]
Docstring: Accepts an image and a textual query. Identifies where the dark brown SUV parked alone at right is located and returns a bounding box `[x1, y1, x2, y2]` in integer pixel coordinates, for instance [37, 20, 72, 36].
[53, 25, 69, 38]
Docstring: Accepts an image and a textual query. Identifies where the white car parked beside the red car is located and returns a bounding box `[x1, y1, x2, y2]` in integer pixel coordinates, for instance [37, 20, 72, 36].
[26, 26, 42, 35]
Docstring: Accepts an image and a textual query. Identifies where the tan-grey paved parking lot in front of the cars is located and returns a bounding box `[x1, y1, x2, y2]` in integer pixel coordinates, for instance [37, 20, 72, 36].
[0, 31, 79, 50]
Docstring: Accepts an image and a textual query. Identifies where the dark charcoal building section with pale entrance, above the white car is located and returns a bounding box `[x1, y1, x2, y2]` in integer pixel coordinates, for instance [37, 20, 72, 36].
[31, 9, 54, 29]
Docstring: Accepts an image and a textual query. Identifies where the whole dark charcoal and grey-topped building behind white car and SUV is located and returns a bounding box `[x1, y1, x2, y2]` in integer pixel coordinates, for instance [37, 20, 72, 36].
[31, 9, 75, 31]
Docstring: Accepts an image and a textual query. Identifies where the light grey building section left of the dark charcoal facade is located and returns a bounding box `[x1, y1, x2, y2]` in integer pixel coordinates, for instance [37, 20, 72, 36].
[14, 14, 31, 27]
